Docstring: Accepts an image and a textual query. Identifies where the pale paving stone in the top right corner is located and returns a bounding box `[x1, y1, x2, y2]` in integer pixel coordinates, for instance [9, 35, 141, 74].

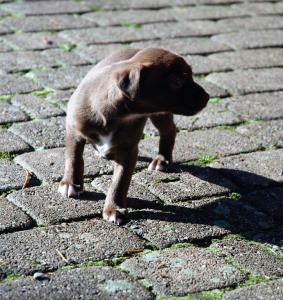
[234, 2, 283, 15]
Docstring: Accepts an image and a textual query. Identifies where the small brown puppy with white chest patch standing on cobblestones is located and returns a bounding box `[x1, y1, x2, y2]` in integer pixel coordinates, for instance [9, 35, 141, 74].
[59, 48, 209, 224]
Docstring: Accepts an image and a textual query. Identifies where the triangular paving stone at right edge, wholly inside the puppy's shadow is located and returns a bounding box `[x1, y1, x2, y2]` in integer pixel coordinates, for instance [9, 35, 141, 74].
[241, 187, 283, 224]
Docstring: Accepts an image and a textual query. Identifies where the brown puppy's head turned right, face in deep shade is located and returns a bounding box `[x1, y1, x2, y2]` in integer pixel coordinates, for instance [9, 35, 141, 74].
[112, 48, 209, 116]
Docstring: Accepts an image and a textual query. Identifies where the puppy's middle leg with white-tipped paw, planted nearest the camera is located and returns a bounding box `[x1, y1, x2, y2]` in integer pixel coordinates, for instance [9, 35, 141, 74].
[103, 146, 138, 225]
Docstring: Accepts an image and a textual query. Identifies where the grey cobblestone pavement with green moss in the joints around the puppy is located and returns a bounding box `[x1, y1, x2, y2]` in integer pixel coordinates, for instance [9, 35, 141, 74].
[0, 0, 283, 300]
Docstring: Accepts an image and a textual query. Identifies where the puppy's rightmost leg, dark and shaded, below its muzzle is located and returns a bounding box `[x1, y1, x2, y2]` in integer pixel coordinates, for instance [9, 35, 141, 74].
[148, 113, 176, 171]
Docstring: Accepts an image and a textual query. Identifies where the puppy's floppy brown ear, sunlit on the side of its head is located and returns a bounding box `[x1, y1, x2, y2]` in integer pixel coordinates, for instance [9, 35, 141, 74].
[117, 63, 151, 101]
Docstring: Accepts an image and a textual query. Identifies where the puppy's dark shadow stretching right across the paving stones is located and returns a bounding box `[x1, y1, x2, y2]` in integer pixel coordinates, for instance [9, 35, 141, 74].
[128, 165, 283, 246]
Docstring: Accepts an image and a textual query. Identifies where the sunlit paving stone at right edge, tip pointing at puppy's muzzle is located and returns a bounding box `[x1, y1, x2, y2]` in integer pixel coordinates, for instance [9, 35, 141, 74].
[206, 68, 283, 94]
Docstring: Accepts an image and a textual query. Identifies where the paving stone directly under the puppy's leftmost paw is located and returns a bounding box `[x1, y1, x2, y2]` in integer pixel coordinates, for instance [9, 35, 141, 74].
[8, 184, 105, 225]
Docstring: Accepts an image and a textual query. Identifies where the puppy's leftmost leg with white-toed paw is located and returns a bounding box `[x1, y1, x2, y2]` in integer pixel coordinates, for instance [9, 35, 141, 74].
[58, 128, 86, 198]
